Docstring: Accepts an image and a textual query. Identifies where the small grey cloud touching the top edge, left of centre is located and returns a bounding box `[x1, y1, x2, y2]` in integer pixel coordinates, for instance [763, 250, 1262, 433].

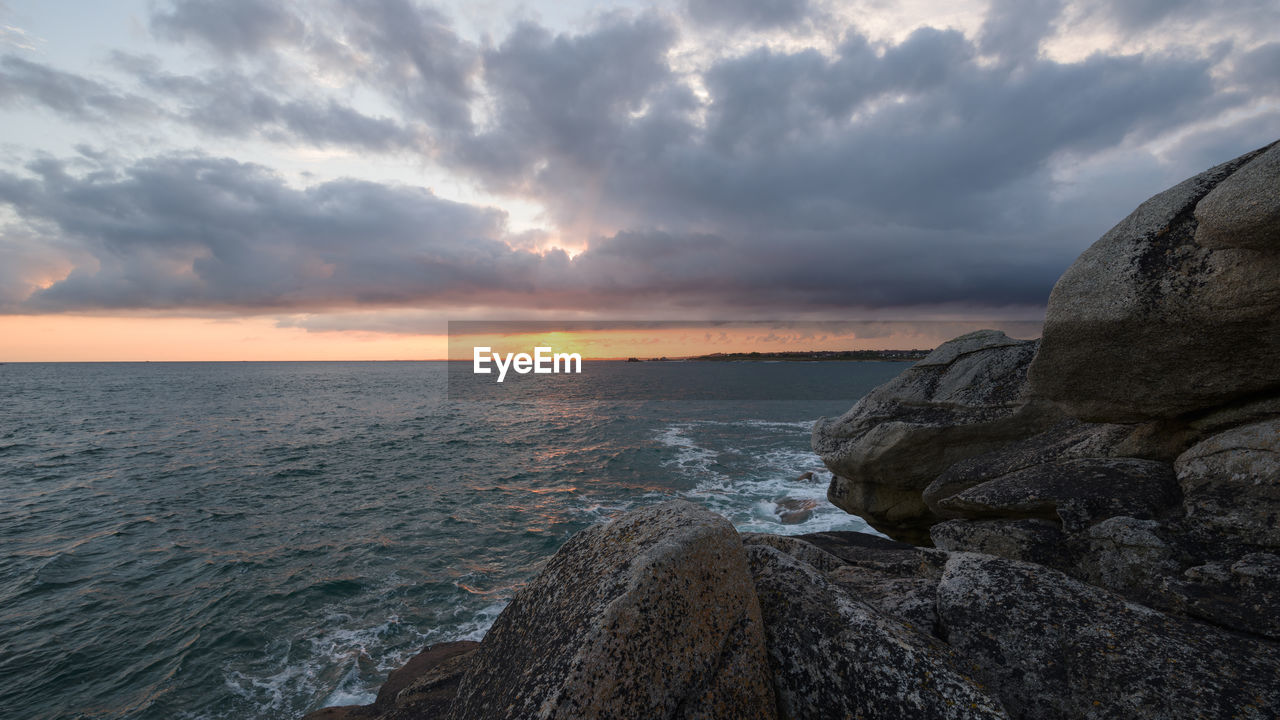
[151, 0, 303, 55]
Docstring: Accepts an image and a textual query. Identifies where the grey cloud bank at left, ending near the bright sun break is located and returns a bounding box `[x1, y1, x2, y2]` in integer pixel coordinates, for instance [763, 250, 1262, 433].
[0, 156, 541, 311]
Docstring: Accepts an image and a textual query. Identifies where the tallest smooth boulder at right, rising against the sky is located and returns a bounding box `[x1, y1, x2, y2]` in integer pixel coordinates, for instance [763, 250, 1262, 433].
[1028, 140, 1280, 423]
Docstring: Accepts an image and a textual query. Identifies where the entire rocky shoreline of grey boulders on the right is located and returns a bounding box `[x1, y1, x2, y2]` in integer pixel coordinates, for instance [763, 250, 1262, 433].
[307, 143, 1280, 720]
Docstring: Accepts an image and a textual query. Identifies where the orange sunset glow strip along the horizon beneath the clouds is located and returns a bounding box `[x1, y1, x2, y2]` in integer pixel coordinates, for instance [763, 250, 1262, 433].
[0, 315, 1038, 363]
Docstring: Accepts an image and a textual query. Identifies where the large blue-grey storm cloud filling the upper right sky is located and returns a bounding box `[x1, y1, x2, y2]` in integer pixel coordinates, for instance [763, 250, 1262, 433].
[452, 14, 1223, 238]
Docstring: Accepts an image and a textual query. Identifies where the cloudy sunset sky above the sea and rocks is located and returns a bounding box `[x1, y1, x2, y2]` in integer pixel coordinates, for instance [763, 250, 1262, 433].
[0, 0, 1280, 361]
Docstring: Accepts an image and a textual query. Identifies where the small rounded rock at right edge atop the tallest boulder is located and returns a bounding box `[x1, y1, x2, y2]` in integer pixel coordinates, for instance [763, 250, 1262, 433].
[1196, 143, 1280, 251]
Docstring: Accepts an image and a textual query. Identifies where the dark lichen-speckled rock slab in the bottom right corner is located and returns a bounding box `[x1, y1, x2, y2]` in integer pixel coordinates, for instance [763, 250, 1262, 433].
[938, 553, 1280, 720]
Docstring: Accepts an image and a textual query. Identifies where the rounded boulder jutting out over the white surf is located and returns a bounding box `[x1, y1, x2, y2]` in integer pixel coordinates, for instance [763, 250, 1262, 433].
[812, 331, 1061, 543]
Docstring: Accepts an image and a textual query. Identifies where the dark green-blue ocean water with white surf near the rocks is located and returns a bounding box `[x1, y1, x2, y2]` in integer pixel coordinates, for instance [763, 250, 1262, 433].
[0, 363, 906, 720]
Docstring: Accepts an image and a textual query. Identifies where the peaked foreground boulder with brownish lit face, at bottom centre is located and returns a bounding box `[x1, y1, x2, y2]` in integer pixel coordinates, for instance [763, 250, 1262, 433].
[448, 501, 776, 720]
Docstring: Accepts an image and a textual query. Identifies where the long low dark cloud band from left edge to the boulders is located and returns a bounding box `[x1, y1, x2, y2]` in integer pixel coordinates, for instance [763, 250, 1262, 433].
[0, 149, 1075, 313]
